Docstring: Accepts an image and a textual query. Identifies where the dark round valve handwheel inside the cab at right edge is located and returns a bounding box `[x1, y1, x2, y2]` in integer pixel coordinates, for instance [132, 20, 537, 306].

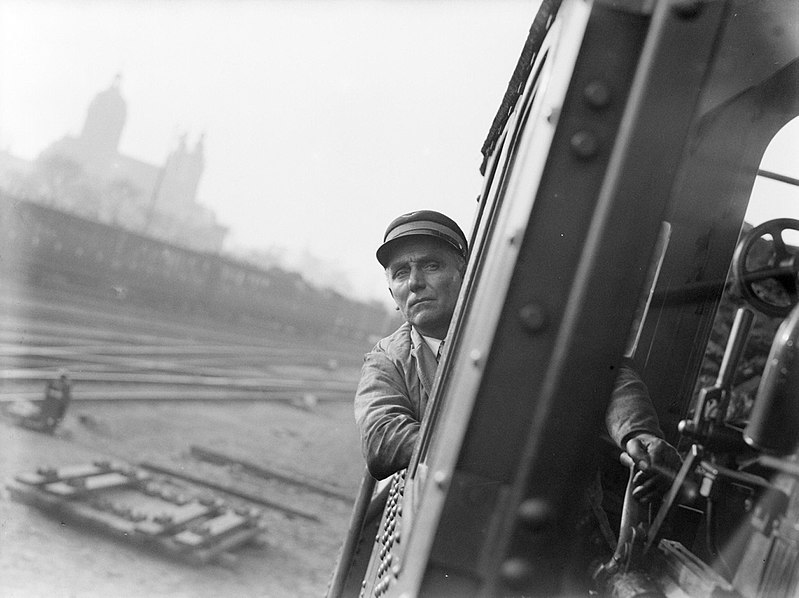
[732, 218, 799, 318]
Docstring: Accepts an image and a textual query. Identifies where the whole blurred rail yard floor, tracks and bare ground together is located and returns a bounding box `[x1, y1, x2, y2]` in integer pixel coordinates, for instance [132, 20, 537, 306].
[0, 285, 369, 596]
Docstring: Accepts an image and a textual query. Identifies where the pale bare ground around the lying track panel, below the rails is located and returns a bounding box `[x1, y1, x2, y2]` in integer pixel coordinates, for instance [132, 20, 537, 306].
[0, 404, 361, 598]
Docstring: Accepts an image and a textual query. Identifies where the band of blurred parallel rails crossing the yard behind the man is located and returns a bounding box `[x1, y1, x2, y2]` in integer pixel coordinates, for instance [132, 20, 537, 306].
[0, 289, 366, 402]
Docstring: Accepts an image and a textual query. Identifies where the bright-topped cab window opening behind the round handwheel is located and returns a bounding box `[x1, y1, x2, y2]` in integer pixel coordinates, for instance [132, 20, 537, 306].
[690, 119, 799, 434]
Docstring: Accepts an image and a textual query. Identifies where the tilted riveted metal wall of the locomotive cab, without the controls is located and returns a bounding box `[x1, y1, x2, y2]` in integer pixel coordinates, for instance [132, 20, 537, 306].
[332, 0, 799, 597]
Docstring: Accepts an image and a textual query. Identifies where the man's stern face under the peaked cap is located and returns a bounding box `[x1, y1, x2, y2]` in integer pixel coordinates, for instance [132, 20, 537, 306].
[386, 236, 463, 339]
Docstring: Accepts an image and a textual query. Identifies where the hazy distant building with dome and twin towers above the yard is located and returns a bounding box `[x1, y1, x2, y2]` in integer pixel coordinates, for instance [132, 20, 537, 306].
[0, 76, 227, 253]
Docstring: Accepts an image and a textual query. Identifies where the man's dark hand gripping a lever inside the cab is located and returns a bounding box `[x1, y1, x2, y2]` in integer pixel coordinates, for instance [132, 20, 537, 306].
[625, 433, 682, 504]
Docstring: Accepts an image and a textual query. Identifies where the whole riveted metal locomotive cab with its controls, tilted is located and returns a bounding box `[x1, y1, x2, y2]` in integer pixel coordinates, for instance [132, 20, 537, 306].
[328, 0, 799, 598]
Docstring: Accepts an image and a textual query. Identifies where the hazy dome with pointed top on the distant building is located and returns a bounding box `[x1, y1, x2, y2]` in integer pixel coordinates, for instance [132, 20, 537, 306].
[80, 75, 128, 157]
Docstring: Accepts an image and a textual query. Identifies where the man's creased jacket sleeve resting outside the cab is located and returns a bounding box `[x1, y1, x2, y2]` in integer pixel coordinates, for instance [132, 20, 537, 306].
[355, 351, 420, 480]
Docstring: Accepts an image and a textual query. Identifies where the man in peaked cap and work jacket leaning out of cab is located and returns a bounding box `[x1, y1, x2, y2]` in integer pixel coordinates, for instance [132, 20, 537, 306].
[355, 210, 679, 502]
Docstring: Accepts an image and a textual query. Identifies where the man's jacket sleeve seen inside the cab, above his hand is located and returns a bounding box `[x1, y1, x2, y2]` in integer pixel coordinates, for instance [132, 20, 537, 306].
[605, 365, 663, 447]
